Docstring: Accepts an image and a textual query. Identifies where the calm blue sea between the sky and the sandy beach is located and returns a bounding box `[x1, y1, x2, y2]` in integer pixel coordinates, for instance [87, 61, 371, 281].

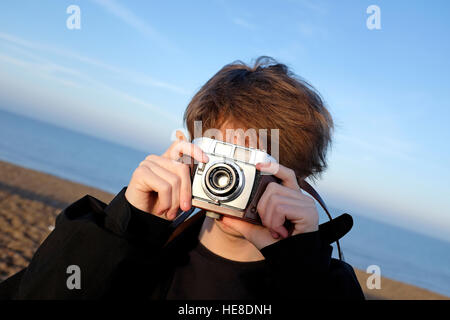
[0, 110, 450, 297]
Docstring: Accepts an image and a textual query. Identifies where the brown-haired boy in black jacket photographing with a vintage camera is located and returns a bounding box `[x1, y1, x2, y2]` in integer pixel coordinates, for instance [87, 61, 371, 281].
[0, 57, 364, 299]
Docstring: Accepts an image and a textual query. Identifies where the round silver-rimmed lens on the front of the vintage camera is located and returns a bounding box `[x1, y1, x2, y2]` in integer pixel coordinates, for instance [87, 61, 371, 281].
[204, 162, 242, 201]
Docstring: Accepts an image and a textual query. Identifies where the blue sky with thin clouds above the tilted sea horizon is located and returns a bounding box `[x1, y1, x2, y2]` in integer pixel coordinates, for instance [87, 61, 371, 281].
[0, 0, 450, 239]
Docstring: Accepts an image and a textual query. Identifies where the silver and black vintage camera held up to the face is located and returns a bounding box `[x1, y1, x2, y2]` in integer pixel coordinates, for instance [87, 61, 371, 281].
[192, 137, 278, 224]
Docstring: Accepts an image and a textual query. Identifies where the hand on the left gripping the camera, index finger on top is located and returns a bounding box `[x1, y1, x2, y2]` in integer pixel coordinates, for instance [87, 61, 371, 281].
[125, 134, 208, 220]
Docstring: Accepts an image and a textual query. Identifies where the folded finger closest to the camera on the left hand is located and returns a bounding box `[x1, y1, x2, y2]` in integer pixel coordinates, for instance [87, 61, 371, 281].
[146, 155, 192, 211]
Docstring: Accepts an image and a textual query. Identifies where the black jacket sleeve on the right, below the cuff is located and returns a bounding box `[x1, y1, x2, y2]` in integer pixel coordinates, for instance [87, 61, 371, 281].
[261, 215, 364, 300]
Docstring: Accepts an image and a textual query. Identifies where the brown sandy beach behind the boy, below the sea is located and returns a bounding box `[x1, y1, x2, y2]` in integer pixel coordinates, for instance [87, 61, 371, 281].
[0, 161, 450, 299]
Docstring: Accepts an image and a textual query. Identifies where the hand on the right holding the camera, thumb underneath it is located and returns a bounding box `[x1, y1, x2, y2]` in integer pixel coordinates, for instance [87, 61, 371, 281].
[222, 163, 319, 250]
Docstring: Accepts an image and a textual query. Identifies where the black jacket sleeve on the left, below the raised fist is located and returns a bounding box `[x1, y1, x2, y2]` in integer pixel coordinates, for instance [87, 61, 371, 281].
[0, 188, 170, 299]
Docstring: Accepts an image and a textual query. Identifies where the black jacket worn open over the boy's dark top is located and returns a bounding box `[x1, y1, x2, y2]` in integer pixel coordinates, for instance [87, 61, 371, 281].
[0, 188, 364, 299]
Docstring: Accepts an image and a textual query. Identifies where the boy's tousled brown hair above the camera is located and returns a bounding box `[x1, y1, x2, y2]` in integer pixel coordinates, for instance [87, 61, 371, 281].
[184, 56, 333, 178]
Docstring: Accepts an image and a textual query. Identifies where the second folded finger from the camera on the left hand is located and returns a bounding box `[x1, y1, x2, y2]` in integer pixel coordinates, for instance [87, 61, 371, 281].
[136, 164, 172, 215]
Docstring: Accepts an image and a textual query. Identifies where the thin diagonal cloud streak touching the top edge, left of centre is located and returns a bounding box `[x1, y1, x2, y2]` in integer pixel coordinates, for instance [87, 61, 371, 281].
[93, 0, 178, 51]
